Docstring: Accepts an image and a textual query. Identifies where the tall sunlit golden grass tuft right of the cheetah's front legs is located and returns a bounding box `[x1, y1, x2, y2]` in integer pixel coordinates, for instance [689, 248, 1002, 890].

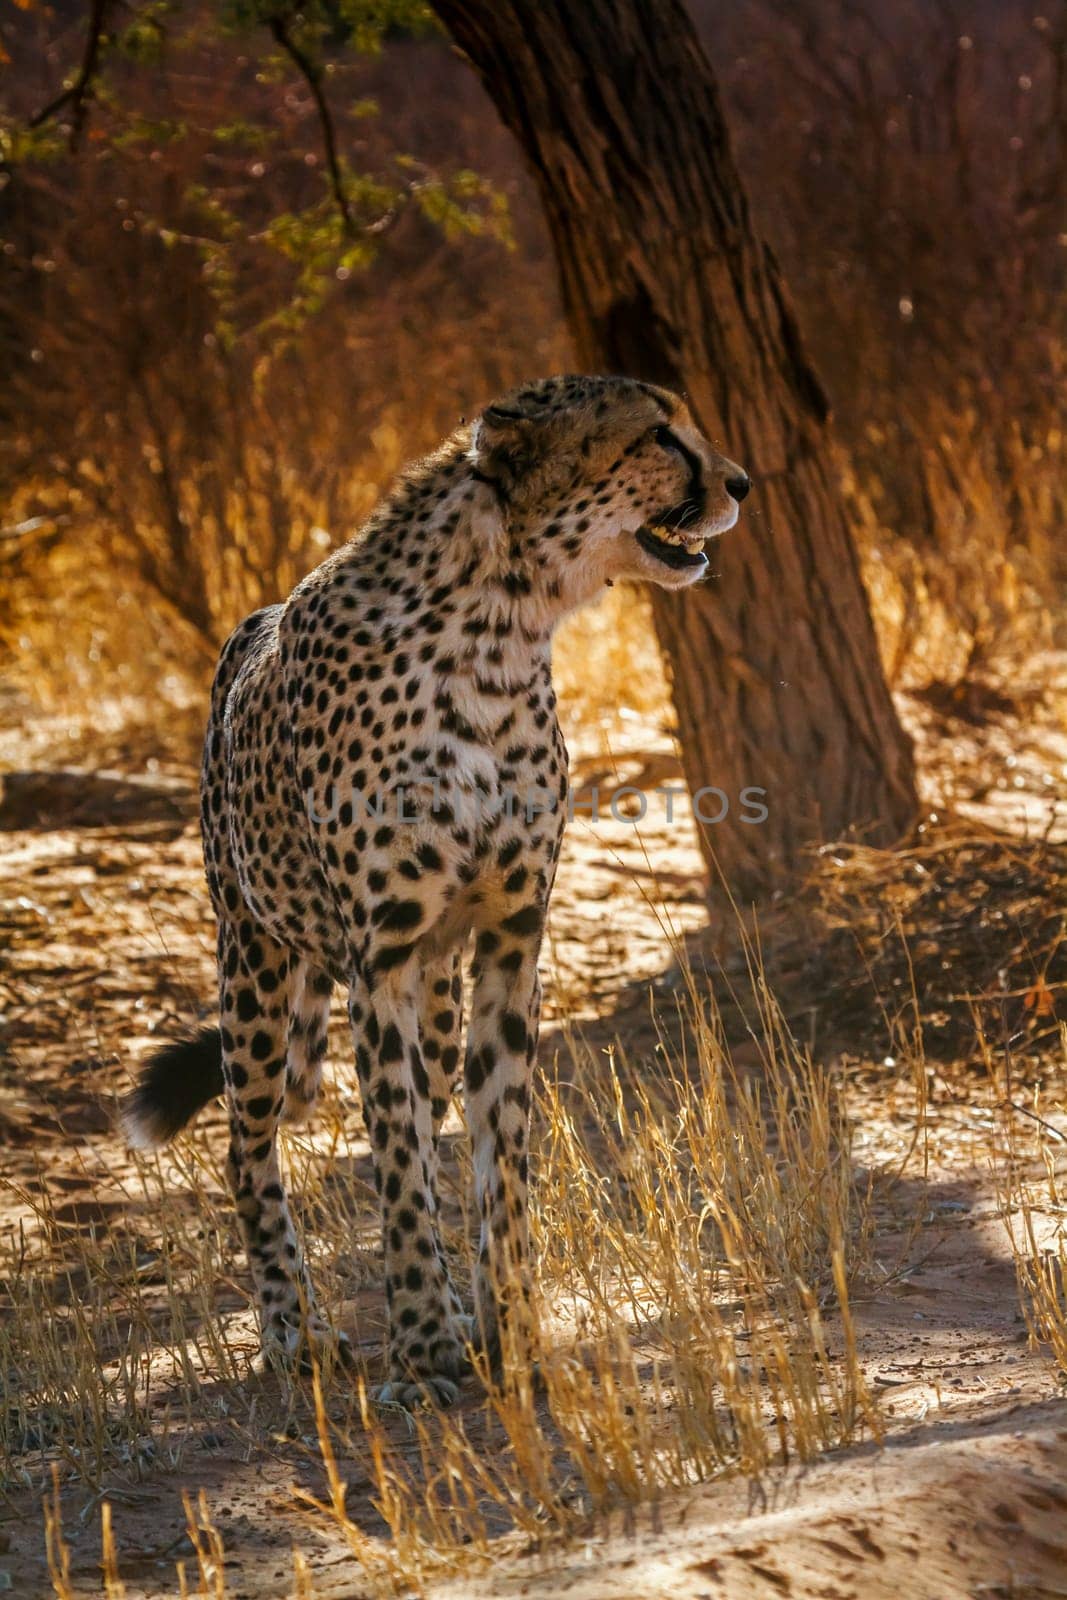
[278, 995, 880, 1594]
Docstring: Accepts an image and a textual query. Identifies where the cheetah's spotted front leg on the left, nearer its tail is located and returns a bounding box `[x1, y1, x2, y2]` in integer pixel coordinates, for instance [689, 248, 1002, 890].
[349, 950, 470, 1406]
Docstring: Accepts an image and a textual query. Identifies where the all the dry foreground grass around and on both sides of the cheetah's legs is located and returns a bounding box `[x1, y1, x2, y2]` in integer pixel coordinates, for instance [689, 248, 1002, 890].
[0, 934, 880, 1595]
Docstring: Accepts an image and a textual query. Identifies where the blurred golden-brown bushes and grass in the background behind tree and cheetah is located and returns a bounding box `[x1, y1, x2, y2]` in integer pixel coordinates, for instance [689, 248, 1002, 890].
[0, 0, 1067, 720]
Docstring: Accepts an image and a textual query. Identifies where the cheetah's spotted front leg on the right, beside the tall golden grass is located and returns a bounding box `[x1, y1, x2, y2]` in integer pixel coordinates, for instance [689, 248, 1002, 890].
[464, 906, 542, 1360]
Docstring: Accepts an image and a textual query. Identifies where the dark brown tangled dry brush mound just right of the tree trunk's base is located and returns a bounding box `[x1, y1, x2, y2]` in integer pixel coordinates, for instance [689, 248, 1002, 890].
[798, 821, 1067, 1061]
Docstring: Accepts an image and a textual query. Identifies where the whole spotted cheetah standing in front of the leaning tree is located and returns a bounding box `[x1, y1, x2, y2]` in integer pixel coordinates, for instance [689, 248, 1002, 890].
[125, 376, 749, 1406]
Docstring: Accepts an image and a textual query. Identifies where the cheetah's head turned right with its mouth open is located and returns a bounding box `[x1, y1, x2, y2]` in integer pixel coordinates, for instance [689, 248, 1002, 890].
[469, 376, 749, 608]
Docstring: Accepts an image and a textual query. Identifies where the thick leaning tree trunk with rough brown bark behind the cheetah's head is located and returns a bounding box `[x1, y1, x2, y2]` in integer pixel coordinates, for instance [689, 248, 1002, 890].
[434, 0, 917, 899]
